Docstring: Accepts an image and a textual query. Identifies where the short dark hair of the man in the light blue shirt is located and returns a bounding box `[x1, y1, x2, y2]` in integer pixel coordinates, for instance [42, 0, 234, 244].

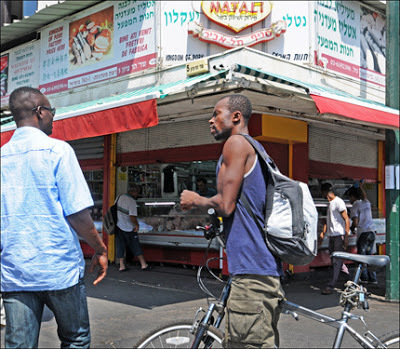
[8, 86, 44, 122]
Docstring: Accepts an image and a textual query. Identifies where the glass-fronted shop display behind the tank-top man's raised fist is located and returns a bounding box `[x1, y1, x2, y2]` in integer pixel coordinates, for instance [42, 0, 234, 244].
[118, 161, 220, 250]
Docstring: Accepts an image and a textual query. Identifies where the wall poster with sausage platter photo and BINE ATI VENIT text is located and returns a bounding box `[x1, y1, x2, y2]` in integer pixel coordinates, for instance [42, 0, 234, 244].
[40, 1, 157, 94]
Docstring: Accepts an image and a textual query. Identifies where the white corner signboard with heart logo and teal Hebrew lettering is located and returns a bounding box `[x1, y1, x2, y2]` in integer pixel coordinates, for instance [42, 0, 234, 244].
[161, 1, 312, 66]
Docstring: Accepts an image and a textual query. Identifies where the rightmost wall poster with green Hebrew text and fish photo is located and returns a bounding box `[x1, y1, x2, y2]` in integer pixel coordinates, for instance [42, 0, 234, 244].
[314, 1, 386, 87]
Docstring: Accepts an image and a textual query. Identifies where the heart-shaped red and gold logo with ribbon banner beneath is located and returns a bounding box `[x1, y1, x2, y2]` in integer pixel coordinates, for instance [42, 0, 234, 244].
[188, 1, 286, 48]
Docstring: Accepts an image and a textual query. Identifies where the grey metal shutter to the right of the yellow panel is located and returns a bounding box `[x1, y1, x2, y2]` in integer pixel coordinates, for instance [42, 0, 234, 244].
[309, 125, 378, 168]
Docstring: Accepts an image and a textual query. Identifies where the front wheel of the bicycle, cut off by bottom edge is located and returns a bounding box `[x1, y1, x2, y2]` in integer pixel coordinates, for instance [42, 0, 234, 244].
[134, 320, 224, 348]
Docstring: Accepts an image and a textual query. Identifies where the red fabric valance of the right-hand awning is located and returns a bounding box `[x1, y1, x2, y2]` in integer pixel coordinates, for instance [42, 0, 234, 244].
[310, 94, 399, 127]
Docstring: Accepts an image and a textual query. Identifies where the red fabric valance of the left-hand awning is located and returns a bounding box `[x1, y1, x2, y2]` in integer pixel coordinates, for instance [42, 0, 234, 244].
[1, 99, 158, 146]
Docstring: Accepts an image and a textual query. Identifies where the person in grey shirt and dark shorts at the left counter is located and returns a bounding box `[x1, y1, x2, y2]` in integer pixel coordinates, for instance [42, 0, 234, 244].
[115, 184, 150, 272]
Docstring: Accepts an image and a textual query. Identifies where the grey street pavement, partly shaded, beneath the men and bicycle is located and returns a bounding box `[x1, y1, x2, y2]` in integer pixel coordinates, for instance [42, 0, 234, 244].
[1, 260, 399, 348]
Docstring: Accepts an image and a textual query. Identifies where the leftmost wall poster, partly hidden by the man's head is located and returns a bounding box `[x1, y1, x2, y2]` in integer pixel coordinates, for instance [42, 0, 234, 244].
[1, 41, 40, 105]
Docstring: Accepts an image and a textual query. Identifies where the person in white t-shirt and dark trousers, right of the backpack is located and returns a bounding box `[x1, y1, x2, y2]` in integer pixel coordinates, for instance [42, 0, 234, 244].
[320, 183, 350, 295]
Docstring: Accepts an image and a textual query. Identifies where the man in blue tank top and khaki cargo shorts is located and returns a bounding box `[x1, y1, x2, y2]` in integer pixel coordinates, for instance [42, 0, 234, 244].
[181, 94, 284, 348]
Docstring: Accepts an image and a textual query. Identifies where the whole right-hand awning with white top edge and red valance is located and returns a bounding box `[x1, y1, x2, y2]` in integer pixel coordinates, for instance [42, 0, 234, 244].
[232, 64, 399, 128]
